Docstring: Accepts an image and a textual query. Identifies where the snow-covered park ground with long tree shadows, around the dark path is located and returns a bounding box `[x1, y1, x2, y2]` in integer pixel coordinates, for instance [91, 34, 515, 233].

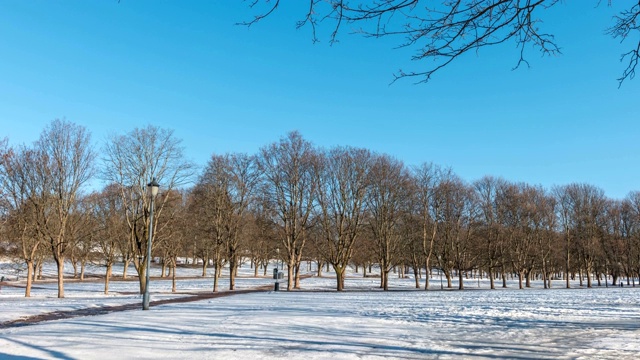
[0, 260, 640, 360]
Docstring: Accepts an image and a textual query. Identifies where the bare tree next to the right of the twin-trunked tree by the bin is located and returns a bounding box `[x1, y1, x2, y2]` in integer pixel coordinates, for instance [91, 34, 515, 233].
[318, 147, 373, 291]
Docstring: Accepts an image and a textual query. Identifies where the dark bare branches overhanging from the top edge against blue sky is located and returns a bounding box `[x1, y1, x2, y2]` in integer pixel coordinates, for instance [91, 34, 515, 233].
[242, 0, 640, 84]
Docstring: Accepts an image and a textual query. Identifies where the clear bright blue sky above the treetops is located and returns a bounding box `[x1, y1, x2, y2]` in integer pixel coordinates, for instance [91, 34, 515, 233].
[0, 0, 640, 198]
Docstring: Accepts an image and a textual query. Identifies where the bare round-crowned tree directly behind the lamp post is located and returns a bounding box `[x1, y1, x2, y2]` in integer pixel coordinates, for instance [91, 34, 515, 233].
[103, 125, 195, 293]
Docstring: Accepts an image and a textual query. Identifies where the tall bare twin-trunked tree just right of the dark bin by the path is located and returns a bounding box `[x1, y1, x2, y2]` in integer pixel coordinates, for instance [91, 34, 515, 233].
[258, 131, 318, 290]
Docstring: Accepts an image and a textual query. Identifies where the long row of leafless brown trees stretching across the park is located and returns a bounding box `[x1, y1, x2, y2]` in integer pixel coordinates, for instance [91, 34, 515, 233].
[0, 120, 640, 297]
